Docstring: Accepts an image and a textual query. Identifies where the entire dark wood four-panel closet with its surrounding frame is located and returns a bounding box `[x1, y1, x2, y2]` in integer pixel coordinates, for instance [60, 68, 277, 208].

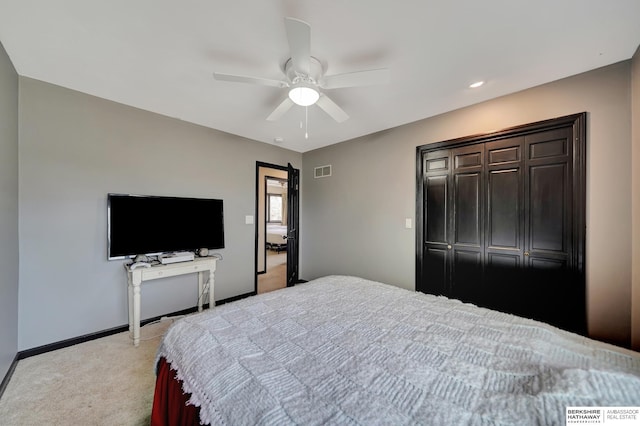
[416, 113, 586, 334]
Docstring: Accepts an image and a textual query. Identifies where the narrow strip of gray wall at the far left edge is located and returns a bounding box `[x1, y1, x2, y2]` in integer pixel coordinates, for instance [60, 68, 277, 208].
[0, 44, 18, 381]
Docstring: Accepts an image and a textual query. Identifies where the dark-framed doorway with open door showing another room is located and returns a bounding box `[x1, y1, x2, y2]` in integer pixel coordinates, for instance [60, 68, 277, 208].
[255, 162, 298, 294]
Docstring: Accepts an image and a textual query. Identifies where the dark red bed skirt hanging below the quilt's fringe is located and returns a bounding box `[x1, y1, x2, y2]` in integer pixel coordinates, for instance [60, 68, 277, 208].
[151, 358, 200, 426]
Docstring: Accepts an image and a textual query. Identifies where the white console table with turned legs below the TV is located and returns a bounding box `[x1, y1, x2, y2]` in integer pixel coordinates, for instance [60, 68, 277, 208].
[124, 257, 218, 346]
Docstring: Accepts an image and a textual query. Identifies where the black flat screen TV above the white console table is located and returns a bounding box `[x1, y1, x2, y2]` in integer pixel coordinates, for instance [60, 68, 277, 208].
[107, 193, 224, 260]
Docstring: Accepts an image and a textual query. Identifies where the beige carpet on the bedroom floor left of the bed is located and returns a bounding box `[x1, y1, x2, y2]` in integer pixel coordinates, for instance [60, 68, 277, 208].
[0, 320, 172, 426]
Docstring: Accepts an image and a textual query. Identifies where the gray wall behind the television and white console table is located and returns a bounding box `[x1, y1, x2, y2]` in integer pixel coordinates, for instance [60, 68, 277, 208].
[13, 77, 302, 350]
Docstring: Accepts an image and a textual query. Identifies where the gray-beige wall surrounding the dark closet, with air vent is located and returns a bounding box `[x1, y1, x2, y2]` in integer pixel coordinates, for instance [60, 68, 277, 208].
[300, 61, 632, 345]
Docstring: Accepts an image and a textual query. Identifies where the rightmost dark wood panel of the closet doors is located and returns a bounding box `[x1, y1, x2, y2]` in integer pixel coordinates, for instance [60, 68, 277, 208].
[522, 127, 585, 333]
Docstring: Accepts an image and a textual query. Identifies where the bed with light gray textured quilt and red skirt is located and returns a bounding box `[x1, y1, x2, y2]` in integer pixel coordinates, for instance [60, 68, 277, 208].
[152, 275, 640, 425]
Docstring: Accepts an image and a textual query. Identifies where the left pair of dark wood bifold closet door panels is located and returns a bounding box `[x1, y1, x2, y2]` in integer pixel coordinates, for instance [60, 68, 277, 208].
[419, 146, 484, 301]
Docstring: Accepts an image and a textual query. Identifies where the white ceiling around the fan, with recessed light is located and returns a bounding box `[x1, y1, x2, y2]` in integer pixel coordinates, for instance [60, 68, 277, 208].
[0, 0, 640, 152]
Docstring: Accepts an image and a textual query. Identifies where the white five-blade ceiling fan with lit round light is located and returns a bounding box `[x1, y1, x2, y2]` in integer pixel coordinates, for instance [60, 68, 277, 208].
[213, 17, 389, 123]
